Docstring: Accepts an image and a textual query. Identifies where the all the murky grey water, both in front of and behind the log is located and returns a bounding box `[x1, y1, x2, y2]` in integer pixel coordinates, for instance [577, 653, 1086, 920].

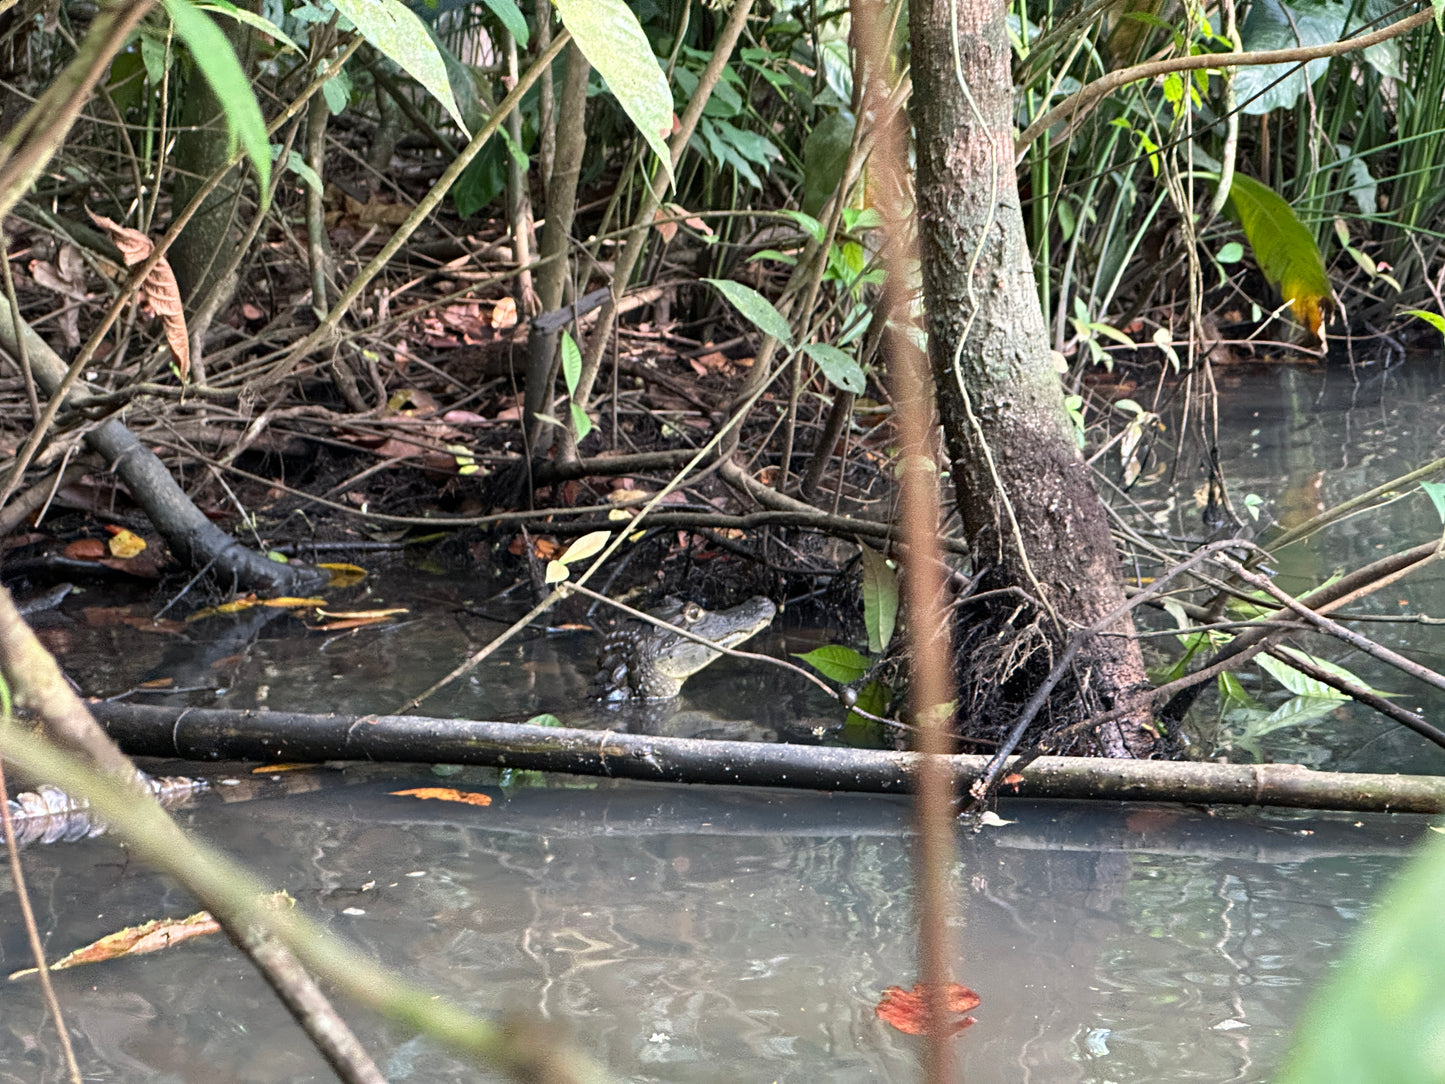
[8, 367, 1445, 1084]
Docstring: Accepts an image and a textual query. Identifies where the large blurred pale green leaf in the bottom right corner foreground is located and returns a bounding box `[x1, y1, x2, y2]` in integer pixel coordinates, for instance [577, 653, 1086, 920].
[1274, 838, 1445, 1084]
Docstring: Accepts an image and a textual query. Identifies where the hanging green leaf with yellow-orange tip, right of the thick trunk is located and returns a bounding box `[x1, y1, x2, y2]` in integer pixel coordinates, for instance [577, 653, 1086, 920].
[1230, 173, 1331, 335]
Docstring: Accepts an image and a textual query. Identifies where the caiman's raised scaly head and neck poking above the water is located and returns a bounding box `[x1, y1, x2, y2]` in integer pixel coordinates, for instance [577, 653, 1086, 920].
[588, 595, 777, 700]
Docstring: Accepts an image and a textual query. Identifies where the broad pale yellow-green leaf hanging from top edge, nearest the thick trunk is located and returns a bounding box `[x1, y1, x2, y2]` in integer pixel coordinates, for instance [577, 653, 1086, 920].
[553, 0, 675, 185]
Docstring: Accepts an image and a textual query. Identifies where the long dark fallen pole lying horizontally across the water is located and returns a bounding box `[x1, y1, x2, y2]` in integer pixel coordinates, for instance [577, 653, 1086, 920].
[90, 702, 1445, 814]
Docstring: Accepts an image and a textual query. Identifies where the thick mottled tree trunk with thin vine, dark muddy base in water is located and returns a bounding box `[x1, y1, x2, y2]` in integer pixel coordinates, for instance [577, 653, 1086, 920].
[910, 0, 1155, 756]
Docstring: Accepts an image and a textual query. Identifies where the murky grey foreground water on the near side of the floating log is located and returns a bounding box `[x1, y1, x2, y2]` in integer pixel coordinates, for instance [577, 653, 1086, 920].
[0, 769, 1422, 1084]
